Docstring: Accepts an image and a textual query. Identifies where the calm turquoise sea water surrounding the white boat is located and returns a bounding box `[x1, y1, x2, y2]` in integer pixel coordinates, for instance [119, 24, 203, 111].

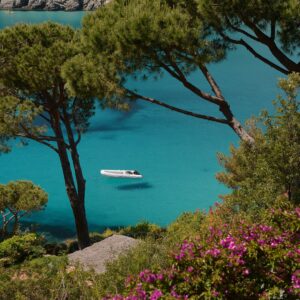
[0, 11, 280, 238]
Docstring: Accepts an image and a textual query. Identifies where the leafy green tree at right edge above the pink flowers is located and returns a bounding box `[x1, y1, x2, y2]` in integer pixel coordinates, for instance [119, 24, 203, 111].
[217, 73, 300, 217]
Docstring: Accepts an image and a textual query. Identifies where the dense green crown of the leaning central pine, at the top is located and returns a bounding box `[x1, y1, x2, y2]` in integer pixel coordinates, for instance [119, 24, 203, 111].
[64, 0, 224, 99]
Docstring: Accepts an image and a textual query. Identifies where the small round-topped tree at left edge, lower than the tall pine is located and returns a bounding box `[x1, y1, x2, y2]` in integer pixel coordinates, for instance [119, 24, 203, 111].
[0, 181, 48, 237]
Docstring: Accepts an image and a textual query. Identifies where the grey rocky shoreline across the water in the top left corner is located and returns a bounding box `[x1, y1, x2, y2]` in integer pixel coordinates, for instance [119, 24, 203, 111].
[0, 0, 111, 11]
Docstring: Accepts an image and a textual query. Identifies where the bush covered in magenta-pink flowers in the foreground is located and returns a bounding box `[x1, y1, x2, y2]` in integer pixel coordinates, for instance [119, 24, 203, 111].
[106, 208, 300, 300]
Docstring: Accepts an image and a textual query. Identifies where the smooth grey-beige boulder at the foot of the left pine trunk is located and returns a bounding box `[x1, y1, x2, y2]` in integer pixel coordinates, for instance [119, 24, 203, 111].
[68, 235, 139, 273]
